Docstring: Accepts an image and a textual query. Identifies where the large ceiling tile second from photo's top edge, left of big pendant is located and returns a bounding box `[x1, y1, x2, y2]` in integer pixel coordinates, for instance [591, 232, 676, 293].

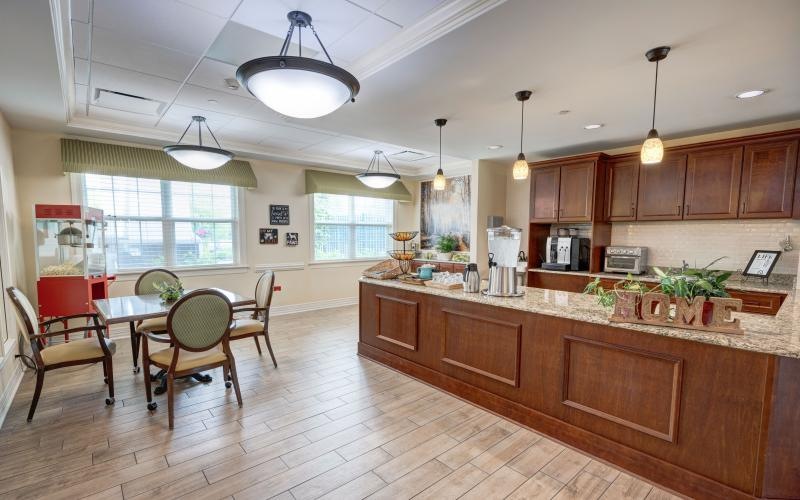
[92, 27, 197, 82]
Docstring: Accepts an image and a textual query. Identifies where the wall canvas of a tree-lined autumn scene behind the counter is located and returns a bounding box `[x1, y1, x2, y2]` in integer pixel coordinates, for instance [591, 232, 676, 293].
[420, 175, 471, 251]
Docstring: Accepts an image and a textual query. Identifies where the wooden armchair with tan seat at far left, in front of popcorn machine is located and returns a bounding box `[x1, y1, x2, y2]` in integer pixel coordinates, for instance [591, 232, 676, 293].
[6, 286, 114, 422]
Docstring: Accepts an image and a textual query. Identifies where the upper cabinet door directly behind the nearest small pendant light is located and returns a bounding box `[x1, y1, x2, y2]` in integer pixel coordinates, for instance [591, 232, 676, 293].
[636, 153, 686, 220]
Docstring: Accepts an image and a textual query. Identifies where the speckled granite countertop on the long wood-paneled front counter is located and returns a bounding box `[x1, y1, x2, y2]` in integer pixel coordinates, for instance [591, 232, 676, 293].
[361, 273, 800, 358]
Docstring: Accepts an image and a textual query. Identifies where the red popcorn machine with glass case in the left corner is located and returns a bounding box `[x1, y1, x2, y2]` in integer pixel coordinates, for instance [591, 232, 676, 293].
[35, 205, 108, 317]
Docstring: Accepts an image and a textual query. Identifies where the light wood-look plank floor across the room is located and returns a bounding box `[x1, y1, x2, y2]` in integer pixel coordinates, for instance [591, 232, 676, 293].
[0, 307, 688, 500]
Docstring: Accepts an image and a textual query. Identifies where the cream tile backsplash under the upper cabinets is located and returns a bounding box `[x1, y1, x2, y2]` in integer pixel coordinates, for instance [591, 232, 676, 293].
[611, 219, 800, 275]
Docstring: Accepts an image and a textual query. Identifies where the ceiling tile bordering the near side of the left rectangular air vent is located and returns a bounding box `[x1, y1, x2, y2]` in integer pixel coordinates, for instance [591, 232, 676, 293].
[92, 62, 180, 103]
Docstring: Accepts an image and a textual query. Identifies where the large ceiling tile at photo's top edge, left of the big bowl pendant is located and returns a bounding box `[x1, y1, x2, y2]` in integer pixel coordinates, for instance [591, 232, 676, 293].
[94, 0, 225, 55]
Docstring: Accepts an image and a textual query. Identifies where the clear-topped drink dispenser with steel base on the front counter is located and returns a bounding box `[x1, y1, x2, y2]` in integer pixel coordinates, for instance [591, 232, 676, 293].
[483, 226, 523, 297]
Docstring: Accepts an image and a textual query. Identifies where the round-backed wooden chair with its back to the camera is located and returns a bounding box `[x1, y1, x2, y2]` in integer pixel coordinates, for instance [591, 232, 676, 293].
[142, 289, 242, 429]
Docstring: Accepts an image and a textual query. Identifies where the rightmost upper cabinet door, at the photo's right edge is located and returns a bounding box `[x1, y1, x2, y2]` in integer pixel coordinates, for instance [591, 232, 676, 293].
[739, 140, 797, 219]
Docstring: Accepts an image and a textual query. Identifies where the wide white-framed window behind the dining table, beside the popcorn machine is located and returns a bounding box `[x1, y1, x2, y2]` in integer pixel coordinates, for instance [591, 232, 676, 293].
[83, 174, 240, 271]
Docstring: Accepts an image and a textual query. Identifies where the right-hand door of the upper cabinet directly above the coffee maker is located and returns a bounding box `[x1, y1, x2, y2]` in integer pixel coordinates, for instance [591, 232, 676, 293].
[558, 160, 595, 222]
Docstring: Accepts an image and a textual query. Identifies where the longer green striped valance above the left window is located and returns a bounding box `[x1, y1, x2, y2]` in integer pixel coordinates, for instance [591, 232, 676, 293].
[61, 139, 258, 188]
